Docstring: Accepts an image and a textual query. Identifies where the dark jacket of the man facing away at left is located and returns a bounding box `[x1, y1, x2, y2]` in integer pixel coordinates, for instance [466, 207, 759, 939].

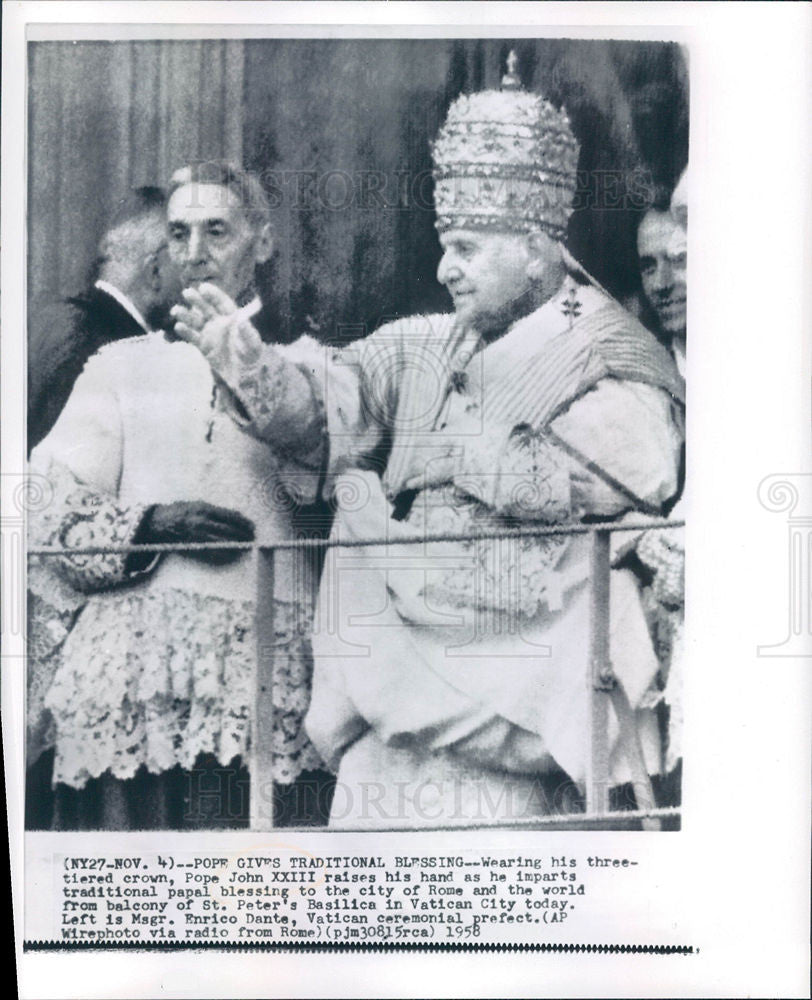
[28, 287, 145, 452]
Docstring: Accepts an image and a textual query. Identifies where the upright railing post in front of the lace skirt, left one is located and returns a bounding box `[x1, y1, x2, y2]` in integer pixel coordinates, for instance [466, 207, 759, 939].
[250, 548, 276, 831]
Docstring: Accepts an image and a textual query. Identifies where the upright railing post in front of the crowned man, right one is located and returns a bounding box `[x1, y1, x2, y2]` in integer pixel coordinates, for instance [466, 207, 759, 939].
[585, 530, 613, 815]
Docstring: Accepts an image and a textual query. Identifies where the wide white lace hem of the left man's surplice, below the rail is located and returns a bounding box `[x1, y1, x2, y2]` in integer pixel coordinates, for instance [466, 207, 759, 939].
[45, 589, 321, 788]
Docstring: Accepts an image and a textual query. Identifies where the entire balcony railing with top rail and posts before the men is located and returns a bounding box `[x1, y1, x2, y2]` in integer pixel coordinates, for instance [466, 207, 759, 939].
[28, 519, 685, 831]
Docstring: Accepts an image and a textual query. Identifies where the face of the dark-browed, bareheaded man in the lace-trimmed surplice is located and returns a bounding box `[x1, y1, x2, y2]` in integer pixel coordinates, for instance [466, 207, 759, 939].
[167, 183, 268, 299]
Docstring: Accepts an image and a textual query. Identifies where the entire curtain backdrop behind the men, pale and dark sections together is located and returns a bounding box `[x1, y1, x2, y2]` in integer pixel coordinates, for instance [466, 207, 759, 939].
[28, 39, 688, 340]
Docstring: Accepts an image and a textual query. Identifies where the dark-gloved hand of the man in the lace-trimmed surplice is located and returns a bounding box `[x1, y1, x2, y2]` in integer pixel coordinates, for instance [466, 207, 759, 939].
[135, 500, 254, 566]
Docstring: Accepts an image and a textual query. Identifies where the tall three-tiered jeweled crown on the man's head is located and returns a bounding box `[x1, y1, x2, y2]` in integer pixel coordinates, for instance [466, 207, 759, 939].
[432, 55, 579, 240]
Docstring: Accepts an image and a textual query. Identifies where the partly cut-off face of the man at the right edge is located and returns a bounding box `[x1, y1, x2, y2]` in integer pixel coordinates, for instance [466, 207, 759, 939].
[637, 209, 687, 335]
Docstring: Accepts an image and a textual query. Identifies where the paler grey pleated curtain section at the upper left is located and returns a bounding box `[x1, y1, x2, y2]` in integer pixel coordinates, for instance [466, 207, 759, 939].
[28, 41, 243, 303]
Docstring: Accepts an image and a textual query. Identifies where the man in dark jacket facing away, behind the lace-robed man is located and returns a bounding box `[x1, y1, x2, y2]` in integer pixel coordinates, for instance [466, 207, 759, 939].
[28, 187, 180, 451]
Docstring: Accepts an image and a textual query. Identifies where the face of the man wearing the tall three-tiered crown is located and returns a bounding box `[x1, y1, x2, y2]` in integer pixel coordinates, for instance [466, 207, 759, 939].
[437, 229, 532, 334]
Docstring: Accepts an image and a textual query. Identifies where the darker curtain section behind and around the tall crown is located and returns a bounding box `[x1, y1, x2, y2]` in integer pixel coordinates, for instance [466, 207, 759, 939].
[244, 39, 688, 339]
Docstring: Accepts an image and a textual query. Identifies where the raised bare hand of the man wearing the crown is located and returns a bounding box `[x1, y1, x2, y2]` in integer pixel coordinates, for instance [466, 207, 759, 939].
[172, 283, 262, 372]
